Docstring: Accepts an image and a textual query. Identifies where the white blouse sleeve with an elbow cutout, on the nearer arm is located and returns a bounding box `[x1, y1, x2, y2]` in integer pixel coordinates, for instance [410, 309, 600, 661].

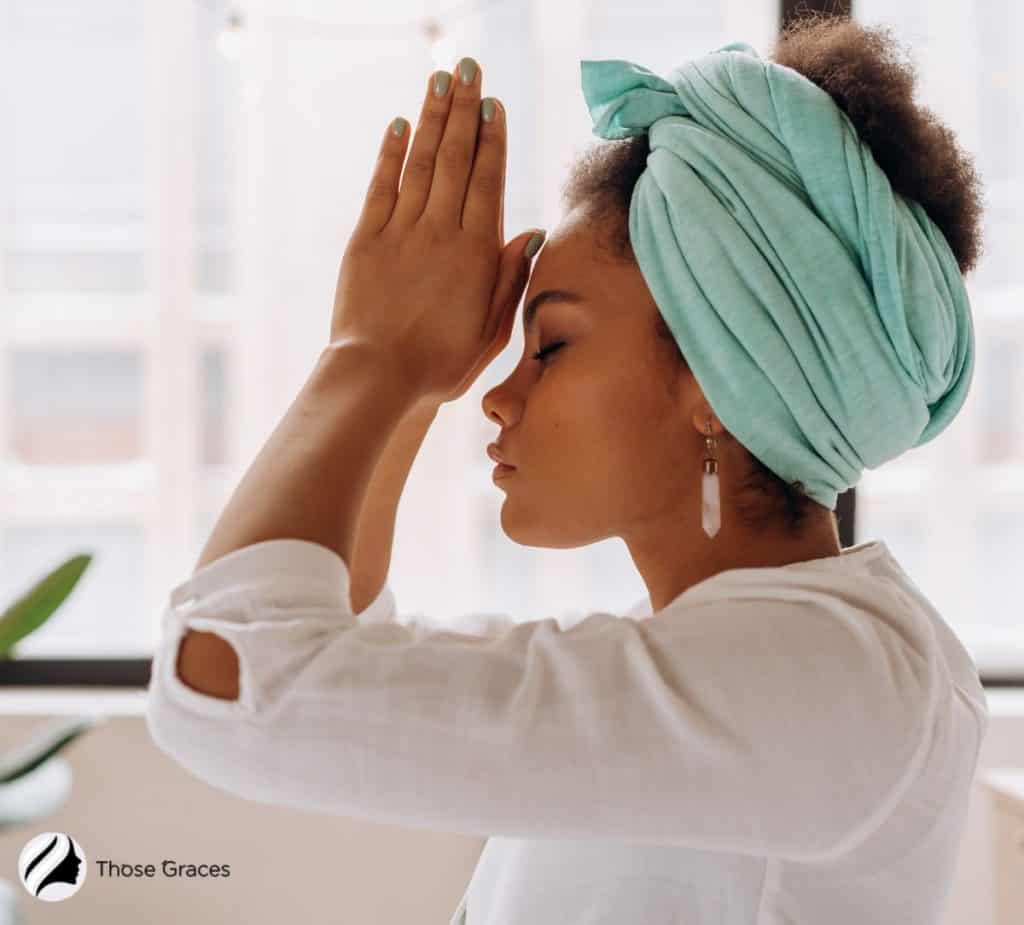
[146, 539, 937, 859]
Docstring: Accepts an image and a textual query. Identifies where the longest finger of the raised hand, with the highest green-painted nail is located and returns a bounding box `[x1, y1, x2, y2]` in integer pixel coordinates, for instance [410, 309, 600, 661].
[423, 58, 482, 228]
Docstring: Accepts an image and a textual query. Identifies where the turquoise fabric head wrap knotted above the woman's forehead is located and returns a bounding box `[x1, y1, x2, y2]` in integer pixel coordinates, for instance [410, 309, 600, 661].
[581, 42, 974, 509]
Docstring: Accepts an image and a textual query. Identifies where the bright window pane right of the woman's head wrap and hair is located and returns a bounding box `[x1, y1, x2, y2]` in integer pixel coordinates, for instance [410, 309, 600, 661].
[854, 0, 1024, 683]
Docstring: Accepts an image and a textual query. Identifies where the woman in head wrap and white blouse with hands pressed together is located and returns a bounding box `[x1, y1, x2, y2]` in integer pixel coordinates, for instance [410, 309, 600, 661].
[146, 14, 987, 925]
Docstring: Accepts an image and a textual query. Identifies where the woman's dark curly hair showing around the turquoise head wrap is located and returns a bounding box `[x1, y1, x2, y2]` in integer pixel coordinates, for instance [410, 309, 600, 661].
[562, 11, 983, 537]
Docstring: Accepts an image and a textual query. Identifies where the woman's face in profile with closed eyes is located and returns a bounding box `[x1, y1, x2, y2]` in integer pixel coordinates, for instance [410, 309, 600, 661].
[482, 204, 703, 548]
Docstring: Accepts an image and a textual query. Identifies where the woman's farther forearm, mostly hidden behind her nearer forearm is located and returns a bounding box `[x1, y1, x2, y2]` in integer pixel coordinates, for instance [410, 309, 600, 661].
[349, 403, 437, 614]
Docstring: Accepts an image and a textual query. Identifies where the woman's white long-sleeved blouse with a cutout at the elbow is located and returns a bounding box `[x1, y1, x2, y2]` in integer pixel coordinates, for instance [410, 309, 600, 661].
[146, 539, 988, 925]
